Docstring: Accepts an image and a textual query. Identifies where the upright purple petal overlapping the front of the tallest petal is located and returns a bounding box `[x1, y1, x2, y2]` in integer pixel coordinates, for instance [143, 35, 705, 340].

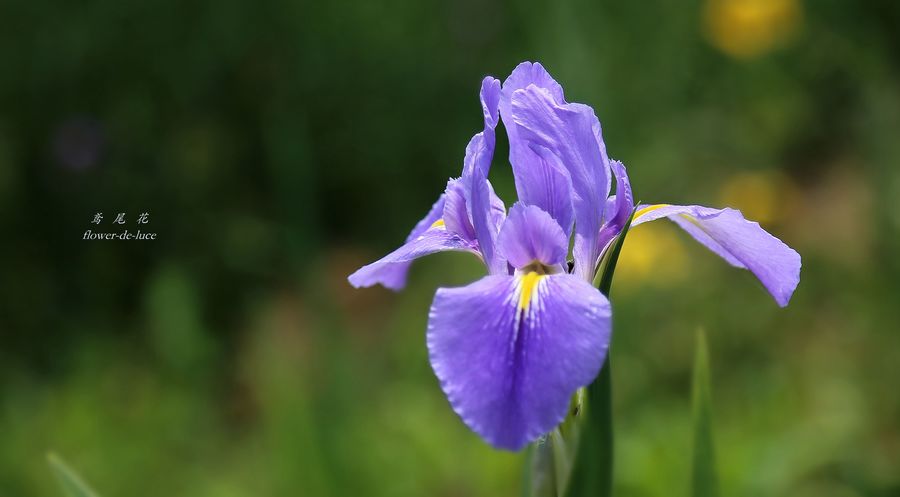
[512, 85, 610, 280]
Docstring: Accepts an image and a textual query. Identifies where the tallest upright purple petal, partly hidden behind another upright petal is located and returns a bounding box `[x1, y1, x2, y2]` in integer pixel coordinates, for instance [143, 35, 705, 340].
[500, 62, 574, 234]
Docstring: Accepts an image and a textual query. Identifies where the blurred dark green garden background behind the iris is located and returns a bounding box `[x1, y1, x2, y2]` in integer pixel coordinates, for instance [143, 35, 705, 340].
[0, 0, 900, 497]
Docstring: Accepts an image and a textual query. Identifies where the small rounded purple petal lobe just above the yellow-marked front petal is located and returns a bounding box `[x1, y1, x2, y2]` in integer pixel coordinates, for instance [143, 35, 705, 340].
[497, 203, 569, 269]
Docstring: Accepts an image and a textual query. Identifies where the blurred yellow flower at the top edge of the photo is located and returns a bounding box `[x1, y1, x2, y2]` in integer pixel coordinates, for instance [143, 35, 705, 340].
[704, 0, 803, 58]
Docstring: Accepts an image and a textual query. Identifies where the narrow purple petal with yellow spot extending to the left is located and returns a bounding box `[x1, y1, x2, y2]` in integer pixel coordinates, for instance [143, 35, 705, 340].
[347, 226, 479, 290]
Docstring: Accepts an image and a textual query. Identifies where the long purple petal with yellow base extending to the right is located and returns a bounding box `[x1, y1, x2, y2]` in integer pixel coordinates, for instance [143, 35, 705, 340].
[631, 204, 801, 307]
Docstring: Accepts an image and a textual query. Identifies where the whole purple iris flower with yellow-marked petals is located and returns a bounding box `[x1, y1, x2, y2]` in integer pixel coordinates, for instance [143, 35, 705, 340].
[349, 62, 800, 450]
